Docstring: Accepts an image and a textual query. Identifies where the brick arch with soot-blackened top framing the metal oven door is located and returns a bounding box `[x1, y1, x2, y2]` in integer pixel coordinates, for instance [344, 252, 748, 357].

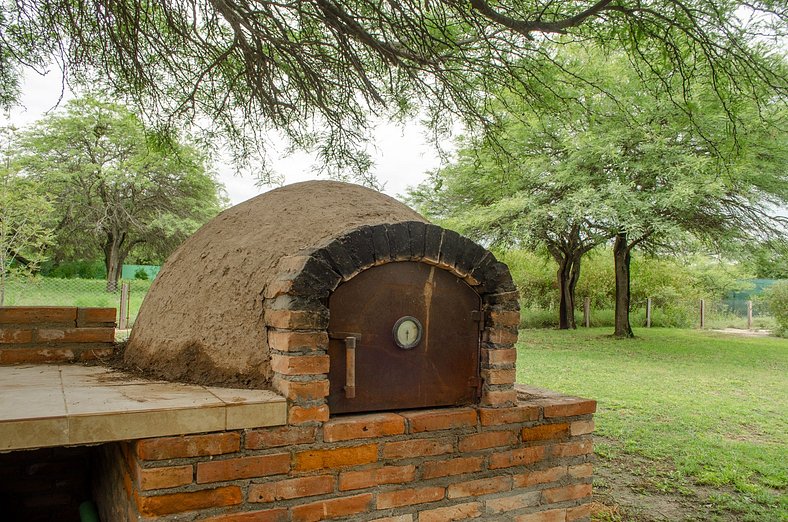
[263, 221, 520, 424]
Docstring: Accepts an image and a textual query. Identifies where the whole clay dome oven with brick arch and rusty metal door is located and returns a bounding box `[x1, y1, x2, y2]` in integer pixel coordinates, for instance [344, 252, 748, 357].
[125, 181, 519, 412]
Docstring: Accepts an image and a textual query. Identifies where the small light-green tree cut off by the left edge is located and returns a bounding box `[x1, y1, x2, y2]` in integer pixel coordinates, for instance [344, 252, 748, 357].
[0, 128, 52, 306]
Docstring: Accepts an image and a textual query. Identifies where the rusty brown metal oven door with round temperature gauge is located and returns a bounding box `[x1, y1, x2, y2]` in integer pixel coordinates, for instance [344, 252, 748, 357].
[328, 262, 481, 413]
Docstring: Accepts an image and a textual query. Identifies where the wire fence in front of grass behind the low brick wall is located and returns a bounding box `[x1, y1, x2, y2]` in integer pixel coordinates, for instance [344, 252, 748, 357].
[0, 277, 152, 328]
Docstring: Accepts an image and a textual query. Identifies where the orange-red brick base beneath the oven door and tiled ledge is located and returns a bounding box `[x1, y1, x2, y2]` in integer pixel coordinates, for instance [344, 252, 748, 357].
[93, 387, 596, 522]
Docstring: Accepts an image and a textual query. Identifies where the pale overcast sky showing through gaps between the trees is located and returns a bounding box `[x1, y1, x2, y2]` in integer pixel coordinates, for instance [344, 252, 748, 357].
[0, 70, 440, 205]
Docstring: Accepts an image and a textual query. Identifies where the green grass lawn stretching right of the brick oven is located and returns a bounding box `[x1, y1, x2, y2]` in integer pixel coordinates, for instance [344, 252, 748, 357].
[517, 328, 788, 520]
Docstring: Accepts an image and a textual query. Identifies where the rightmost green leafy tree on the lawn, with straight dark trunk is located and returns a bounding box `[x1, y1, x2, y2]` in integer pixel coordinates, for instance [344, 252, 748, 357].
[410, 46, 788, 337]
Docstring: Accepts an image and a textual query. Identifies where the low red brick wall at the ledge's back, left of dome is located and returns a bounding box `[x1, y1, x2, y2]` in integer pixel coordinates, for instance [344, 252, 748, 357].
[0, 306, 115, 364]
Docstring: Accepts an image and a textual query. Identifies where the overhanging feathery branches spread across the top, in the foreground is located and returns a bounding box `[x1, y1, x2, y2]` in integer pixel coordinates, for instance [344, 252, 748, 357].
[0, 0, 788, 177]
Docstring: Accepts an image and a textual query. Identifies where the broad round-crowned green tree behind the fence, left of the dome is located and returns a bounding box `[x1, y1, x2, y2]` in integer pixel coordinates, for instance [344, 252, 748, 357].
[0, 97, 226, 291]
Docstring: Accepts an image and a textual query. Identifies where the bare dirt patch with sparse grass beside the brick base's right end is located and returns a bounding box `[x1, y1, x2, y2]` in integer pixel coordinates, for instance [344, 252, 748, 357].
[592, 437, 738, 522]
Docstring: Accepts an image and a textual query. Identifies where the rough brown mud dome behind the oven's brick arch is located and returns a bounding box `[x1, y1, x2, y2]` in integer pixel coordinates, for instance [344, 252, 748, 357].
[124, 181, 426, 388]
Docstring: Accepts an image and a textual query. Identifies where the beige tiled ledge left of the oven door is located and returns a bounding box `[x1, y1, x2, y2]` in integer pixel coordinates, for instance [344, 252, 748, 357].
[0, 364, 287, 451]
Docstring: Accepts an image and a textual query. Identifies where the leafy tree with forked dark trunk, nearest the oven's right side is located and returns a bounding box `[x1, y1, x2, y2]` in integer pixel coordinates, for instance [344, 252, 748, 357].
[409, 132, 609, 329]
